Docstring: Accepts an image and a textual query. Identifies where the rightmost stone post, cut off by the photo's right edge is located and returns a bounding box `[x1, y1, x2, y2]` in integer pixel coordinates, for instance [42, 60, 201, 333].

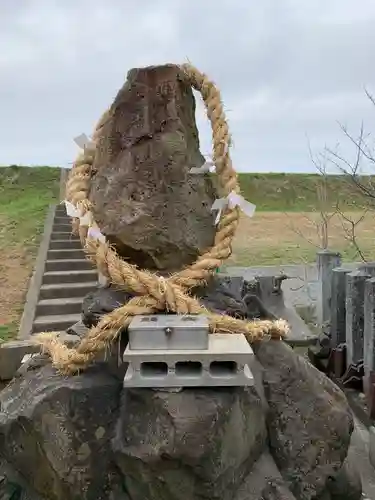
[363, 278, 375, 394]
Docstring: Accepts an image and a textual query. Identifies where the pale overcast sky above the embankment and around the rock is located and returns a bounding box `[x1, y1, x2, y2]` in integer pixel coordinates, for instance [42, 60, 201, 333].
[0, 0, 375, 172]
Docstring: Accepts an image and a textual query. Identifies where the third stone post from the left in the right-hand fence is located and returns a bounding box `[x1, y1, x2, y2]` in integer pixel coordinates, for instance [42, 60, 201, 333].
[346, 271, 371, 366]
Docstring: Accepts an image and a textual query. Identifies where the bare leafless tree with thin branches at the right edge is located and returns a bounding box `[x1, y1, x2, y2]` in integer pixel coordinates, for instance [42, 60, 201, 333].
[290, 90, 375, 268]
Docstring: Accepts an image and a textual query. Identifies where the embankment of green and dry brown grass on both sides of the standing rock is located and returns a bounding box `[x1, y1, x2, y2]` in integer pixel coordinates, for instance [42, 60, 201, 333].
[0, 167, 375, 339]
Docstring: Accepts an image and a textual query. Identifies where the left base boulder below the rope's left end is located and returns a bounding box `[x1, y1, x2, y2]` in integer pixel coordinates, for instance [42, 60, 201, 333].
[0, 365, 121, 500]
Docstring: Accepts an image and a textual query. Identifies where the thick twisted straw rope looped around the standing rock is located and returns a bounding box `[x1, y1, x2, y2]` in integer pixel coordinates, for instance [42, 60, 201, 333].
[35, 64, 288, 375]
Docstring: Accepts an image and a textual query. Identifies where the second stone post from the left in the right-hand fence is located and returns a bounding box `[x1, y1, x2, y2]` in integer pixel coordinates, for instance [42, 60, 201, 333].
[329, 267, 351, 349]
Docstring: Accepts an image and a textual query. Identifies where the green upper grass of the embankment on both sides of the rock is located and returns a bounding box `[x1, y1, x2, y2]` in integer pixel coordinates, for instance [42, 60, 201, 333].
[0, 170, 361, 232]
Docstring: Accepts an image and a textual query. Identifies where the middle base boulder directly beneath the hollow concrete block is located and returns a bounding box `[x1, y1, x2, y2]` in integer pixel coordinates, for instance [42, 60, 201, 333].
[112, 388, 267, 500]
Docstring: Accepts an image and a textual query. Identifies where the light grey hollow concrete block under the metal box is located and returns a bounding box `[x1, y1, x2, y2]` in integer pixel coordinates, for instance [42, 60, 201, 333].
[123, 334, 254, 387]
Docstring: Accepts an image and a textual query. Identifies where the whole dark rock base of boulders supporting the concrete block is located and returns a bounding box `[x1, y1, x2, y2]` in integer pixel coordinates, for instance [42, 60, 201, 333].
[0, 341, 361, 500]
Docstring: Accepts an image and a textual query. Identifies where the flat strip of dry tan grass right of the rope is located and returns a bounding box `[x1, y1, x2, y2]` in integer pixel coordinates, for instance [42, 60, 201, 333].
[230, 212, 375, 266]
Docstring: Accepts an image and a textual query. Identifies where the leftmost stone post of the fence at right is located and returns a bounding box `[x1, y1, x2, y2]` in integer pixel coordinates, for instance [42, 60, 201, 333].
[317, 250, 341, 325]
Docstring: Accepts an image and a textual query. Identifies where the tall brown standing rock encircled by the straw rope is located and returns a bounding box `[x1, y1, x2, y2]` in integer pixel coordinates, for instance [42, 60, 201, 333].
[89, 64, 216, 271]
